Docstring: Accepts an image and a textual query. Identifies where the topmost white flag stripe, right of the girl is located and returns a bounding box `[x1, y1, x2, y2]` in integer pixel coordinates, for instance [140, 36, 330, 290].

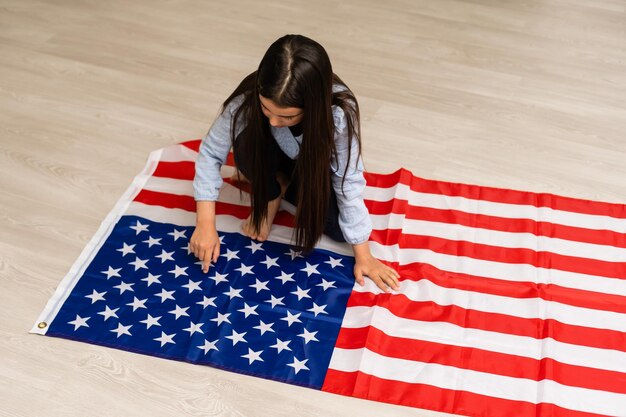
[364, 184, 626, 233]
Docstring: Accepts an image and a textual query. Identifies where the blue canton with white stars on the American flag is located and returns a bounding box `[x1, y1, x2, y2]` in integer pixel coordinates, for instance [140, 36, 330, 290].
[48, 216, 354, 388]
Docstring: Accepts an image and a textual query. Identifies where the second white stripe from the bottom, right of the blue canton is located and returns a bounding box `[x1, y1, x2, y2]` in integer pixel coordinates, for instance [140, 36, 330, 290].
[341, 306, 626, 373]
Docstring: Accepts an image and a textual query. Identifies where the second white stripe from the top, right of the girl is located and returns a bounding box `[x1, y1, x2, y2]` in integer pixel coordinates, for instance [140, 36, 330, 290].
[370, 214, 626, 262]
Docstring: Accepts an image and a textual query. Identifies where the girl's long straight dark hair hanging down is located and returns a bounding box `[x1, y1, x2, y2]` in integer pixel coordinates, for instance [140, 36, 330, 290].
[223, 35, 361, 252]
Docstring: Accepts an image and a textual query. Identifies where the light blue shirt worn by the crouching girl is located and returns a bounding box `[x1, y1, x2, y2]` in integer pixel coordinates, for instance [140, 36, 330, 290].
[193, 97, 372, 245]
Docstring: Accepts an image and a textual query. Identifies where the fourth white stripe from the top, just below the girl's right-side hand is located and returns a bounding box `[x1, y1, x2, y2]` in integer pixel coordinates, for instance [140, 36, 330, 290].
[354, 279, 626, 332]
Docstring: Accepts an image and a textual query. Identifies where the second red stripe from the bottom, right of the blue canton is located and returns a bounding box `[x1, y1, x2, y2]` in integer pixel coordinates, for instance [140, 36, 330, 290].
[335, 326, 626, 394]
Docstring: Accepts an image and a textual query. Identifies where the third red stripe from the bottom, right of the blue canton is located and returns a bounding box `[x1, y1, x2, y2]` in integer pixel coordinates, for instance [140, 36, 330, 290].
[347, 292, 626, 352]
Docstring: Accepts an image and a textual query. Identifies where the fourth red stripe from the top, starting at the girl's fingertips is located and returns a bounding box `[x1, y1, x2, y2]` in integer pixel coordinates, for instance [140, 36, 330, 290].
[385, 262, 626, 314]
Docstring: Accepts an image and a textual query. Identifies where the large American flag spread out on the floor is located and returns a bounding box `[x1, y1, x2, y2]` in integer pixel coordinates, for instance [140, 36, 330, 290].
[32, 141, 626, 417]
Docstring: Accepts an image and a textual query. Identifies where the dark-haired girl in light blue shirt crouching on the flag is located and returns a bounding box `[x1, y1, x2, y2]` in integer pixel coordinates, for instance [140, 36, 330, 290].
[190, 35, 399, 291]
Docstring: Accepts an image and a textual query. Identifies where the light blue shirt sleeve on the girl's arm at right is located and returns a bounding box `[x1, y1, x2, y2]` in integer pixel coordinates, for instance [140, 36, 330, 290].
[331, 107, 372, 245]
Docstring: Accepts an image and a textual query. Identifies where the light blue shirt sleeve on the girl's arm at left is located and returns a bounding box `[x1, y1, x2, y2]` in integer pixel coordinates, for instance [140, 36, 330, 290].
[193, 96, 243, 201]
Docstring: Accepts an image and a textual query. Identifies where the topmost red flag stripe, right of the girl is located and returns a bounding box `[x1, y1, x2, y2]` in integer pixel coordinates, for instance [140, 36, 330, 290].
[365, 169, 626, 219]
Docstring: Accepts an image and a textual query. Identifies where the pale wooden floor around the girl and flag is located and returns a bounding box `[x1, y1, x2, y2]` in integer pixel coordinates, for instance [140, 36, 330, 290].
[0, 0, 626, 417]
